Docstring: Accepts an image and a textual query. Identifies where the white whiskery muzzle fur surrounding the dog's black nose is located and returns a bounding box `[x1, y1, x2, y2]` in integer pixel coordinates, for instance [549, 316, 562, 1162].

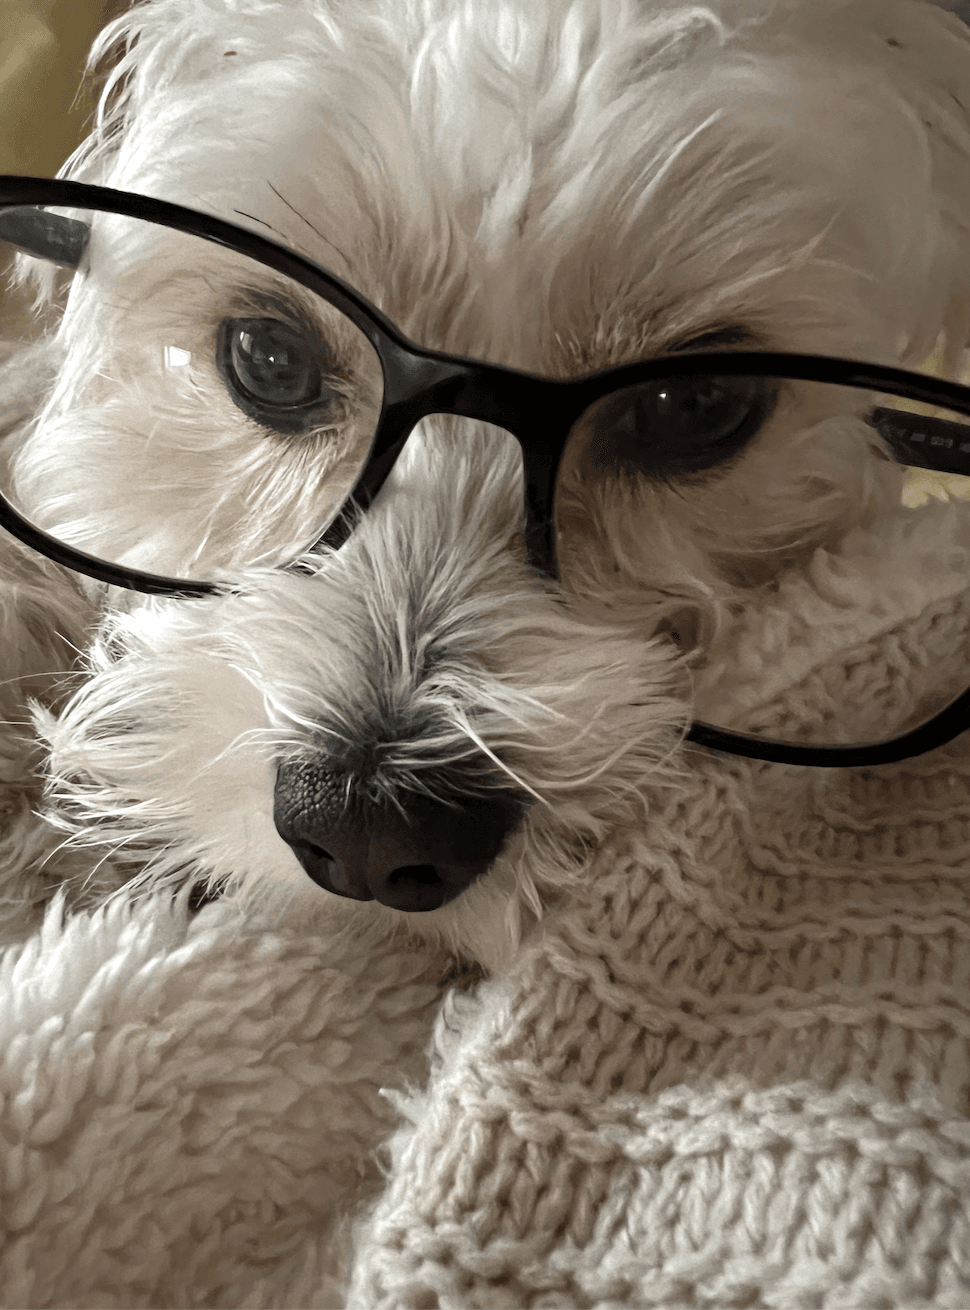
[34, 443, 684, 967]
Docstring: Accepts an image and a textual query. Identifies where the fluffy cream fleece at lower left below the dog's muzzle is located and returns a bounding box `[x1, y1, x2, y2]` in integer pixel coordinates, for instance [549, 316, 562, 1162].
[0, 896, 442, 1310]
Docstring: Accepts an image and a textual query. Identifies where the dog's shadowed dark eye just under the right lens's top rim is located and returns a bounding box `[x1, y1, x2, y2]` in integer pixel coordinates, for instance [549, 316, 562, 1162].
[585, 376, 777, 477]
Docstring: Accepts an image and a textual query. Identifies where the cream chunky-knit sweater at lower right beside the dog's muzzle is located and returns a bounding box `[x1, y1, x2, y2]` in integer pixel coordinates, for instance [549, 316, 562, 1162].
[345, 506, 970, 1310]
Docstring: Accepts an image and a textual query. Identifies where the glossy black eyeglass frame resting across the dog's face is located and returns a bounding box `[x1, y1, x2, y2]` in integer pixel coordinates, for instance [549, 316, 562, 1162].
[0, 176, 970, 768]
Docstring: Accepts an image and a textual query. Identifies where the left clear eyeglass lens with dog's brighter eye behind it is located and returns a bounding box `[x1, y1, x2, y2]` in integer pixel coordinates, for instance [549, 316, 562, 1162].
[0, 214, 383, 582]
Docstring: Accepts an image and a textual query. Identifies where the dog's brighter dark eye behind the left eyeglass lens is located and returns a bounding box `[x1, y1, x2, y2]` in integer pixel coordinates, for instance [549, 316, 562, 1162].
[218, 318, 341, 432]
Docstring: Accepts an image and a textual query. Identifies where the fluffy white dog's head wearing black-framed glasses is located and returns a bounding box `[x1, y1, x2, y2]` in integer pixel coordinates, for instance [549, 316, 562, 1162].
[4, 0, 970, 967]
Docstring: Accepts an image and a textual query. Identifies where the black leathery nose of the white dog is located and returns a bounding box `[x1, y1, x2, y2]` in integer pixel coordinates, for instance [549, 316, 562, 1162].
[273, 762, 523, 912]
